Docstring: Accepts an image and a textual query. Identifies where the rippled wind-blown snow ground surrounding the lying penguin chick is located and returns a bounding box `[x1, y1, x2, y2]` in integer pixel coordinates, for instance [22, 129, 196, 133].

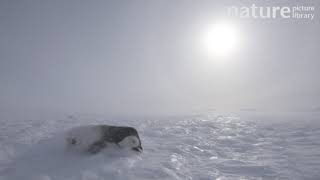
[0, 112, 320, 180]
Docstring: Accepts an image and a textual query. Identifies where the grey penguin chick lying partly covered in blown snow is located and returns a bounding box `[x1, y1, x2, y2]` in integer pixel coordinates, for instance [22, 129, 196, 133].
[66, 125, 142, 154]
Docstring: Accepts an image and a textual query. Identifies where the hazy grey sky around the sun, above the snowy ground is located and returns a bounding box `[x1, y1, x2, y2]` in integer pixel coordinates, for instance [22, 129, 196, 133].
[0, 0, 320, 114]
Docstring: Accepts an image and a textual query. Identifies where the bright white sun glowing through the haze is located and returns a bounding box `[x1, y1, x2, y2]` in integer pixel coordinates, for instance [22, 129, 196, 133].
[203, 21, 239, 57]
